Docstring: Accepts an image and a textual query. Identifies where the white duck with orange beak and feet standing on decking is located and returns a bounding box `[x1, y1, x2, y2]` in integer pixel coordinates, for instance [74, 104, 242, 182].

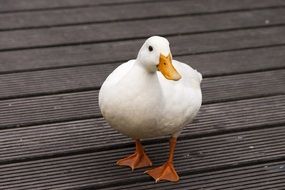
[98, 36, 202, 182]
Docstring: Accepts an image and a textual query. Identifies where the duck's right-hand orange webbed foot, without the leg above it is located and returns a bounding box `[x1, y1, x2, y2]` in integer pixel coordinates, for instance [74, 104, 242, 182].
[145, 162, 179, 183]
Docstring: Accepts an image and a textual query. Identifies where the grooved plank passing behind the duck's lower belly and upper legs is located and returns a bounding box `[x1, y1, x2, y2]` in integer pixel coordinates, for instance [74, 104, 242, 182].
[0, 96, 285, 164]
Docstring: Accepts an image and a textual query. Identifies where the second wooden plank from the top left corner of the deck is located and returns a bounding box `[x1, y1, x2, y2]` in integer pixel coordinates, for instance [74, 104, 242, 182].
[0, 0, 285, 30]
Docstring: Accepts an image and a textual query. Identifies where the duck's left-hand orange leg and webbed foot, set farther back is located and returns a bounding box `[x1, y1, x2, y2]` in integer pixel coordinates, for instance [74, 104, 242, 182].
[117, 139, 152, 170]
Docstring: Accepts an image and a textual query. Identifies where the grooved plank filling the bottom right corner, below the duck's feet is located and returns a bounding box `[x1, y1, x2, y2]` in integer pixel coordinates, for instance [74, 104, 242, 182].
[103, 161, 285, 190]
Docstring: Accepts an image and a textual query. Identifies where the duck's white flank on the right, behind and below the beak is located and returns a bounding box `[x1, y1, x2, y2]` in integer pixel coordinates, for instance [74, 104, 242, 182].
[155, 60, 202, 136]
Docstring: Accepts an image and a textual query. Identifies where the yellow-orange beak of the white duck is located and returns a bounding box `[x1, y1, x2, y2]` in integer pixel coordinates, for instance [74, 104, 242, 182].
[157, 54, 181, 81]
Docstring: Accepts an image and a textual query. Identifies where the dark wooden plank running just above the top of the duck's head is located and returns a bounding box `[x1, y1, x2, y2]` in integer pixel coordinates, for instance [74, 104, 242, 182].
[0, 9, 285, 50]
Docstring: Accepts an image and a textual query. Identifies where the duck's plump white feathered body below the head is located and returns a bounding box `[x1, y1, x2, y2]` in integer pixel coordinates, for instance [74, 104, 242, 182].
[99, 36, 202, 139]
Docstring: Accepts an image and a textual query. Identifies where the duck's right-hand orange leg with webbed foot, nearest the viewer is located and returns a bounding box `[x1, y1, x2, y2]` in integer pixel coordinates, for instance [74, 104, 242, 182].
[145, 137, 179, 182]
